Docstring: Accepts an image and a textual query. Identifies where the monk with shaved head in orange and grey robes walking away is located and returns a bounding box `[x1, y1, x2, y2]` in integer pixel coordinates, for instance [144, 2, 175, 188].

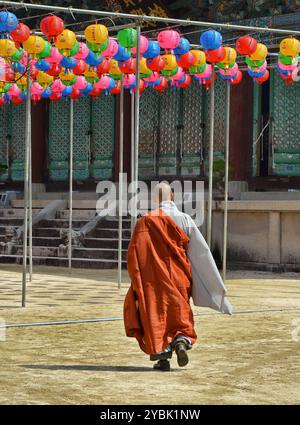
[124, 182, 232, 371]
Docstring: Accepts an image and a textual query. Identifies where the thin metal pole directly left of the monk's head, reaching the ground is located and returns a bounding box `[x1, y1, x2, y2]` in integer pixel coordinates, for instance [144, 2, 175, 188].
[118, 77, 124, 289]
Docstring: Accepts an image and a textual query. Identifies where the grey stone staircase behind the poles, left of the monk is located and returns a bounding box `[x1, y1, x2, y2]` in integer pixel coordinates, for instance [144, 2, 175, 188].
[0, 199, 130, 269]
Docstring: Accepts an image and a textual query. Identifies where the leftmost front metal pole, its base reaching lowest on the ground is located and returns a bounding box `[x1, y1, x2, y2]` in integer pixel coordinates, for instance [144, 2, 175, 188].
[22, 55, 31, 307]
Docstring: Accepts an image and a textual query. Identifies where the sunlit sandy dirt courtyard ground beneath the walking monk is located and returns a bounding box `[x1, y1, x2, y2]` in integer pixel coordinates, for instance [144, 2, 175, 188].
[0, 265, 300, 404]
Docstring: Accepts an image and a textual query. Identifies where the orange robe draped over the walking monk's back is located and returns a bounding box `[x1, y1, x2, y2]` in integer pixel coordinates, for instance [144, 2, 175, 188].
[124, 210, 197, 354]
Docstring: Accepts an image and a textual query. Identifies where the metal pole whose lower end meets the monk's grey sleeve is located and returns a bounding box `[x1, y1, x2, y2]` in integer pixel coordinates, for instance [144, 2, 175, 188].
[206, 64, 215, 248]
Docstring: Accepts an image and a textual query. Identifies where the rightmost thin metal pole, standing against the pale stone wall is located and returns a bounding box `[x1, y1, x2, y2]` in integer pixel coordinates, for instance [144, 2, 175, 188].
[223, 81, 230, 282]
